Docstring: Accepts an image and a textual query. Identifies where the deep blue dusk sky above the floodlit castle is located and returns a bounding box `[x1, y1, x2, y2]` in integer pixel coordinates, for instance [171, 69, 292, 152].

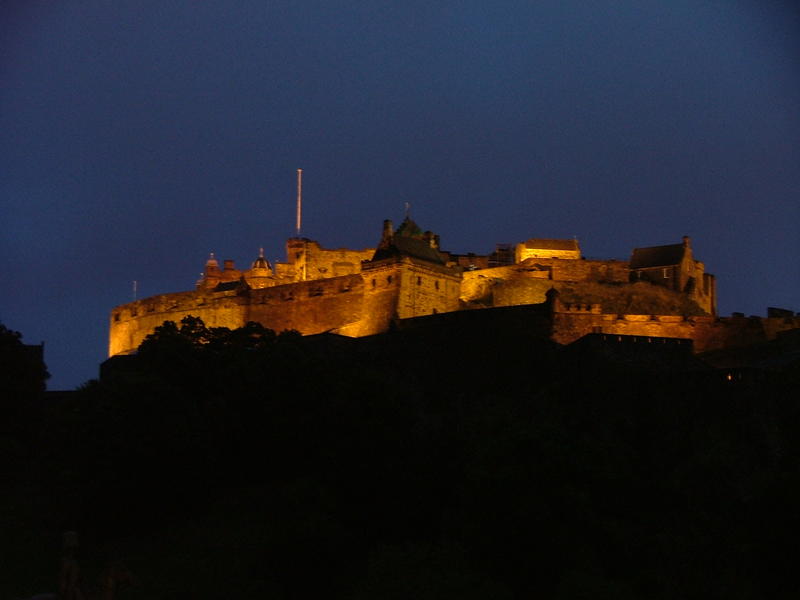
[0, 0, 800, 389]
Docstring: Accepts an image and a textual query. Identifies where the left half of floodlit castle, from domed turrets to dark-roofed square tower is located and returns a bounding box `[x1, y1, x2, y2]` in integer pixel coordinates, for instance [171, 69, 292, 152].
[109, 219, 461, 356]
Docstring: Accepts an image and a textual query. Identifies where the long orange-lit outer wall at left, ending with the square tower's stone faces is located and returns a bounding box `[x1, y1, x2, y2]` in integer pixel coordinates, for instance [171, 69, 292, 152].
[109, 263, 466, 356]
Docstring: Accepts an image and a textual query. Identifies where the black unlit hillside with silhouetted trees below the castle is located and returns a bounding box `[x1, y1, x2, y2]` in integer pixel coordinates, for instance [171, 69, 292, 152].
[0, 320, 800, 600]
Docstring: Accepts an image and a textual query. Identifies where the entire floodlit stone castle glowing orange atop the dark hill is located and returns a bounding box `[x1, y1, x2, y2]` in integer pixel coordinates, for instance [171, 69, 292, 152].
[109, 217, 800, 356]
